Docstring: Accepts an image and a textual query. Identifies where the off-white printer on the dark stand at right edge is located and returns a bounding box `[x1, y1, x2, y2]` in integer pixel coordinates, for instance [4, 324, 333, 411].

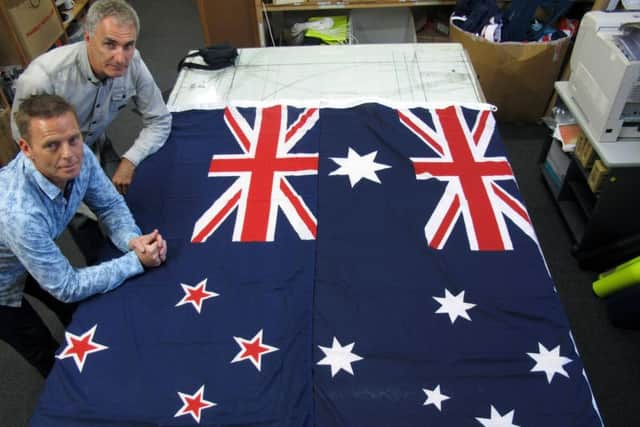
[568, 11, 640, 143]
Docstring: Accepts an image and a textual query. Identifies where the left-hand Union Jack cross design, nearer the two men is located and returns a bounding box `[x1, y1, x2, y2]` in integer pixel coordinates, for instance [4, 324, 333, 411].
[191, 106, 319, 243]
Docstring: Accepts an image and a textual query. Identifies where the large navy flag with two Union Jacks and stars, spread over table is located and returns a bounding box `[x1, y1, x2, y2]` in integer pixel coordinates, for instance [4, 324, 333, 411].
[31, 104, 602, 427]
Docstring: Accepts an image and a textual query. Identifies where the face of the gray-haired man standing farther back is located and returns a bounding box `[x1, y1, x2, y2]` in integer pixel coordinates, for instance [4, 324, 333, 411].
[84, 16, 136, 80]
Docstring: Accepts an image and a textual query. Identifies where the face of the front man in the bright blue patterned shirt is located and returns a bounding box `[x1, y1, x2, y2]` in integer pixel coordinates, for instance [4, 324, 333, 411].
[20, 112, 83, 190]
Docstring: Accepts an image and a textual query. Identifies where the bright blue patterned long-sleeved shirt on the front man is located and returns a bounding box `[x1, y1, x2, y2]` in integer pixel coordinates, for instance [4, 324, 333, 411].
[0, 145, 144, 307]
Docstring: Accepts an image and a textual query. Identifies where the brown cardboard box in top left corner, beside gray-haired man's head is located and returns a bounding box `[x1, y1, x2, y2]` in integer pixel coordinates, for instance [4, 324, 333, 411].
[2, 0, 64, 62]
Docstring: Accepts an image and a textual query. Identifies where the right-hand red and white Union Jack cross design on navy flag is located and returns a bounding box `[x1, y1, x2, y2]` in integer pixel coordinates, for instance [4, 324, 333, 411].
[398, 106, 536, 251]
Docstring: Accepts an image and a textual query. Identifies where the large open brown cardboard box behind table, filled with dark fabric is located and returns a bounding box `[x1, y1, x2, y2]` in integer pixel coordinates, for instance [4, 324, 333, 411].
[449, 23, 570, 122]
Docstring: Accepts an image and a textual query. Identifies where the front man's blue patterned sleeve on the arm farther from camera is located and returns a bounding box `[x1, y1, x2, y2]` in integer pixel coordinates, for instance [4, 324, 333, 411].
[83, 145, 142, 252]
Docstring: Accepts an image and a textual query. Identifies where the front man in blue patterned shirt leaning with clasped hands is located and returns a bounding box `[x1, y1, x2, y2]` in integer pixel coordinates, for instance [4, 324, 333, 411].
[0, 94, 167, 377]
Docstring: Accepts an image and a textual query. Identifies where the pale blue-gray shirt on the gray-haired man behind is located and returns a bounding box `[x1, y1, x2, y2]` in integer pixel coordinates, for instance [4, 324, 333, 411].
[11, 41, 171, 166]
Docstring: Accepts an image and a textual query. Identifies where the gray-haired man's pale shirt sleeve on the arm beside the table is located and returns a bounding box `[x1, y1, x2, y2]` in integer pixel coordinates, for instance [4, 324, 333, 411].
[123, 52, 171, 166]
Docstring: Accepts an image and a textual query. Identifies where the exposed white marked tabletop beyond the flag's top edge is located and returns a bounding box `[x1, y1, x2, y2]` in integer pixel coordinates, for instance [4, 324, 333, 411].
[168, 43, 484, 111]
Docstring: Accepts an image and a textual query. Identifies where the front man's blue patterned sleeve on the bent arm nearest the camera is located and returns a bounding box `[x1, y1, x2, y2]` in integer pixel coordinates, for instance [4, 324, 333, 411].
[4, 213, 144, 302]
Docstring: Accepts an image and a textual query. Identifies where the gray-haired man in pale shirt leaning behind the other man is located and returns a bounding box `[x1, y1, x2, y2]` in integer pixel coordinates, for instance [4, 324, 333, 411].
[11, 0, 171, 194]
